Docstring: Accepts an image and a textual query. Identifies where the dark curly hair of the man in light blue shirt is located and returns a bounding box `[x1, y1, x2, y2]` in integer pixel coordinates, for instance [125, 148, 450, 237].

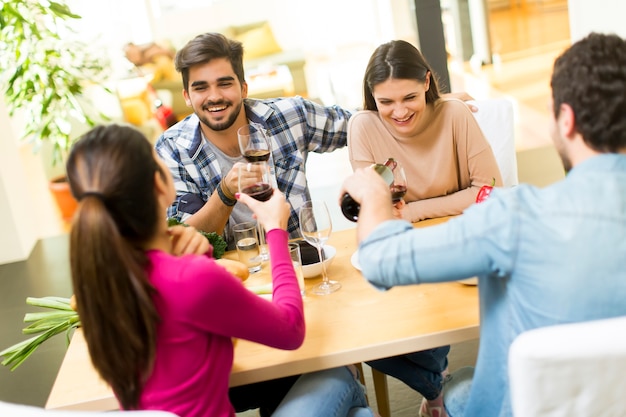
[550, 33, 626, 153]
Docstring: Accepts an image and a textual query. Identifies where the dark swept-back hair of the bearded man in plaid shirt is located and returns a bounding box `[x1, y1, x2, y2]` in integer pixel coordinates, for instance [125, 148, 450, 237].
[176, 33, 245, 91]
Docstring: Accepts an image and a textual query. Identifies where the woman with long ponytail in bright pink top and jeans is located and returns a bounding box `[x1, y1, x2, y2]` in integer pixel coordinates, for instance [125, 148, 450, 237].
[67, 125, 371, 417]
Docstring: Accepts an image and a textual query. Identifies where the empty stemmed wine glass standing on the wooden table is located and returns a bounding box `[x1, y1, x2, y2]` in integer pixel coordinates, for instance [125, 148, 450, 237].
[298, 200, 341, 295]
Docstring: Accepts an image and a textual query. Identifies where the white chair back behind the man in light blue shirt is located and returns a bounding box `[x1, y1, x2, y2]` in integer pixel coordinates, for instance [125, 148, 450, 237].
[509, 317, 626, 417]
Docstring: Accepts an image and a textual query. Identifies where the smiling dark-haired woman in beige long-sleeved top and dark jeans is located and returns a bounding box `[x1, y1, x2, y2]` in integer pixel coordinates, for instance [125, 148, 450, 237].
[348, 41, 502, 417]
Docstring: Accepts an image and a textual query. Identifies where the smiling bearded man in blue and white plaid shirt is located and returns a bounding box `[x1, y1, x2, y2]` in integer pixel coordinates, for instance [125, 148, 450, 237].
[151, 33, 350, 249]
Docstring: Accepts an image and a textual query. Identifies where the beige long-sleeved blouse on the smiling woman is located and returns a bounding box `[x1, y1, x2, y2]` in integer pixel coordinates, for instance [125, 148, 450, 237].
[348, 98, 502, 222]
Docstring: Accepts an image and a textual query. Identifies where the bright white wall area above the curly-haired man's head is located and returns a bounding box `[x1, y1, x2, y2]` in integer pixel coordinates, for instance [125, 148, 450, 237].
[568, 0, 626, 42]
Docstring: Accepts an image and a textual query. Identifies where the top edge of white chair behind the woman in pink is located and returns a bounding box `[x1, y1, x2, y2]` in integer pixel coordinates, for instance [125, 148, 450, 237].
[0, 401, 177, 417]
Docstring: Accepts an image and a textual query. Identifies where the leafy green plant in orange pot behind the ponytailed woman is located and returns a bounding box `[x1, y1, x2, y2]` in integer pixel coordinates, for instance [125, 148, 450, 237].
[0, 0, 110, 218]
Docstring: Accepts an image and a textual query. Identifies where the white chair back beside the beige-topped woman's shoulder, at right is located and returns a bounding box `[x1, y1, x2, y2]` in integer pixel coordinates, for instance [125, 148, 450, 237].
[468, 98, 519, 187]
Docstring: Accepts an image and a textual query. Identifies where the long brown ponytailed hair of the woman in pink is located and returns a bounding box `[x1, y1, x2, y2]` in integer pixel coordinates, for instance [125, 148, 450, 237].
[67, 125, 164, 409]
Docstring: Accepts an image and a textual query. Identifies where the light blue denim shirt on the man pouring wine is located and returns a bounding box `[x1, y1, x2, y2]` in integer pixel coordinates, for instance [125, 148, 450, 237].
[359, 154, 626, 416]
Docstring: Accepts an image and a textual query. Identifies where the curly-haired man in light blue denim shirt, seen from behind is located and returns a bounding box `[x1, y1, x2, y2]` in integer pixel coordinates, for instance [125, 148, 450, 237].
[342, 34, 626, 417]
